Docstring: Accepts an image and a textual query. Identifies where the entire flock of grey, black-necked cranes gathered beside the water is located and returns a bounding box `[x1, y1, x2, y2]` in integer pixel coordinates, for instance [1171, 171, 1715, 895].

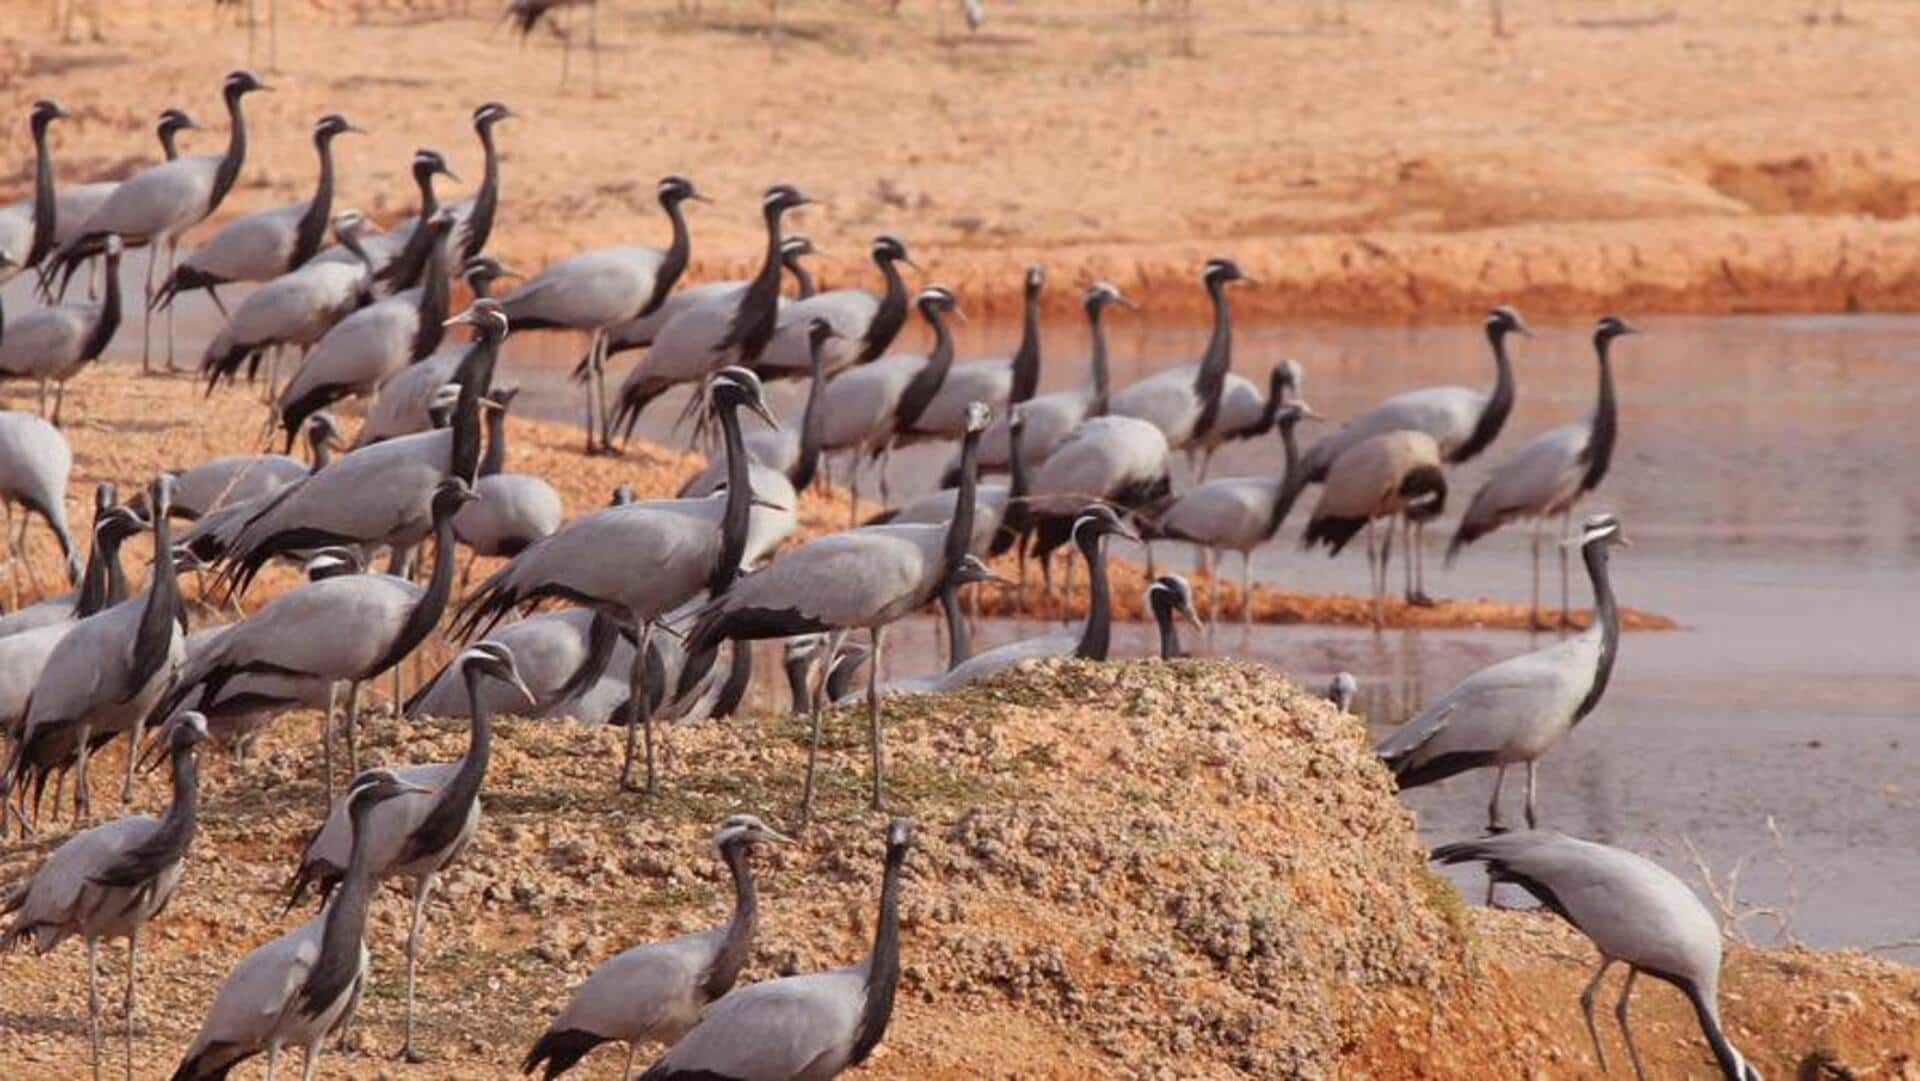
[0, 71, 1757, 1079]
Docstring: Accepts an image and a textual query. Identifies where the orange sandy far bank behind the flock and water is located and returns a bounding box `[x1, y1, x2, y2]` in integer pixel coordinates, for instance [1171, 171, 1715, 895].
[0, 0, 1920, 319]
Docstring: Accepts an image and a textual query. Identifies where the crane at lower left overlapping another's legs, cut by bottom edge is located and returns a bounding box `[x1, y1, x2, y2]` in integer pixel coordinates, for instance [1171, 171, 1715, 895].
[173, 770, 415, 1081]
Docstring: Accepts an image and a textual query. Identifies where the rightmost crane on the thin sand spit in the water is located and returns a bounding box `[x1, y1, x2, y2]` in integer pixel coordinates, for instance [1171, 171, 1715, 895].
[1446, 315, 1636, 628]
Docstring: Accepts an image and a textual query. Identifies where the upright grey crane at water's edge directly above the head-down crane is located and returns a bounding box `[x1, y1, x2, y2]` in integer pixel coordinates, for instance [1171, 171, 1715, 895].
[1375, 515, 1628, 828]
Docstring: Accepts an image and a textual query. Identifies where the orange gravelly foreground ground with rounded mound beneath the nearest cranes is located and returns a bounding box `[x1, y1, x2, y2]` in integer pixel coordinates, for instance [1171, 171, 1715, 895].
[0, 662, 1920, 1079]
